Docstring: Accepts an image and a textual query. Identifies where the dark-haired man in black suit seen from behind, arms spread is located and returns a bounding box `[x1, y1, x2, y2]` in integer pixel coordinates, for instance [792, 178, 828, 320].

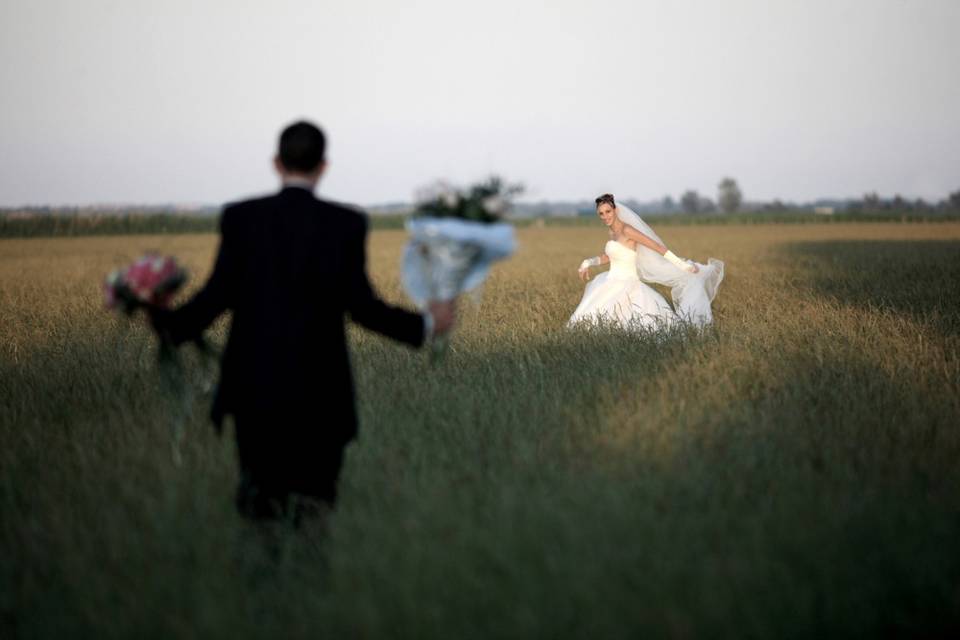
[151, 122, 454, 520]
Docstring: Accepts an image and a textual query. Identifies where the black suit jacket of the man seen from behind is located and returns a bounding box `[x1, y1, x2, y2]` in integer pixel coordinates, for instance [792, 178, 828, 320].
[153, 187, 424, 450]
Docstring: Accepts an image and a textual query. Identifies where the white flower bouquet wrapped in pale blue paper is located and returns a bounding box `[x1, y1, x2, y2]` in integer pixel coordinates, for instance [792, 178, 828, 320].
[401, 177, 522, 357]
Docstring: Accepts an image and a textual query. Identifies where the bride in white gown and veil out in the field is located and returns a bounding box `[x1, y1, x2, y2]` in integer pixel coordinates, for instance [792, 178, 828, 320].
[567, 193, 723, 329]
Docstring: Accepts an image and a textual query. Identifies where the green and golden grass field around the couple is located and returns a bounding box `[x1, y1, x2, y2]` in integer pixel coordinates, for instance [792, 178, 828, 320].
[0, 223, 960, 638]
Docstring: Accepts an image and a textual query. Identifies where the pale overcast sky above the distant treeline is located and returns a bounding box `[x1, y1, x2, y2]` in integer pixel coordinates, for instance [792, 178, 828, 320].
[0, 0, 960, 206]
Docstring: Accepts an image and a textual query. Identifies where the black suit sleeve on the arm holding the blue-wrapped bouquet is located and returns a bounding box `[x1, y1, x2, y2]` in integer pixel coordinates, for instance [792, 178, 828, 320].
[346, 217, 425, 347]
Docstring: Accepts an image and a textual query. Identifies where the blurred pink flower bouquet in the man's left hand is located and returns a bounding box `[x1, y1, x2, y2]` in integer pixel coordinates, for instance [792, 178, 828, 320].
[103, 253, 187, 315]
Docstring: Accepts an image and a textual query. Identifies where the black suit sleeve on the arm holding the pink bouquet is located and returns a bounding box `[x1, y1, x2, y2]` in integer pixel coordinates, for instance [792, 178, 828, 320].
[150, 208, 238, 344]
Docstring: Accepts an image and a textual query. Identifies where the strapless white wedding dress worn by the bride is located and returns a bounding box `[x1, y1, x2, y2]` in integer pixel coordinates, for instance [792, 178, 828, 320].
[567, 240, 676, 330]
